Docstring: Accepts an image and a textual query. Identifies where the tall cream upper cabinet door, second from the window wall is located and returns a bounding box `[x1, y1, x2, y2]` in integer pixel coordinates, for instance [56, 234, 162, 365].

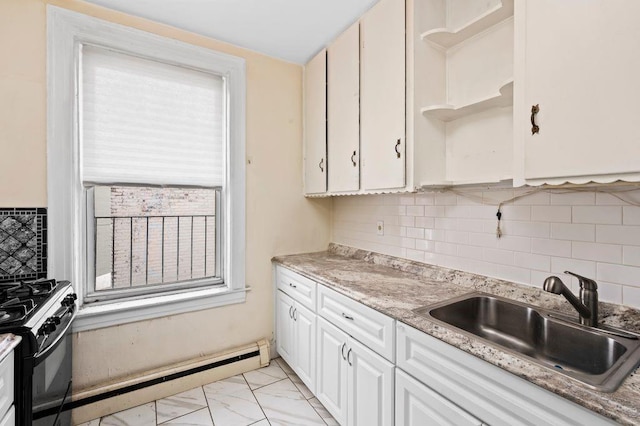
[327, 22, 360, 192]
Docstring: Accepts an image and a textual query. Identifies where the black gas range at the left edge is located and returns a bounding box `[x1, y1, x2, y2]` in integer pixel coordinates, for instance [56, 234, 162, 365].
[0, 279, 77, 426]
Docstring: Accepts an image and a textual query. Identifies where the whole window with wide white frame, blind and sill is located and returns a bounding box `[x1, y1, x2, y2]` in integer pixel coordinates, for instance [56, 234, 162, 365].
[47, 6, 245, 330]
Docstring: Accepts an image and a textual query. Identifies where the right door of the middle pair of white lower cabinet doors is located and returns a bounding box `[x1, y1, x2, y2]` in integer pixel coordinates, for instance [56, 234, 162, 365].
[347, 339, 394, 426]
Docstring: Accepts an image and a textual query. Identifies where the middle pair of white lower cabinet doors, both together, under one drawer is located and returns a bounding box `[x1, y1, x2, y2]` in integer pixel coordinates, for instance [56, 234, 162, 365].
[316, 318, 395, 426]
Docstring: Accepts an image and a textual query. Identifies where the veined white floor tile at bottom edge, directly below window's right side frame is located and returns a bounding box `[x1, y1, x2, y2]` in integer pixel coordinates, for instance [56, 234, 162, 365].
[203, 375, 265, 426]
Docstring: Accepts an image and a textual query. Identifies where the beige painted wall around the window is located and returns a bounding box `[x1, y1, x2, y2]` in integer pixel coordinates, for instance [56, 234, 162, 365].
[0, 0, 331, 389]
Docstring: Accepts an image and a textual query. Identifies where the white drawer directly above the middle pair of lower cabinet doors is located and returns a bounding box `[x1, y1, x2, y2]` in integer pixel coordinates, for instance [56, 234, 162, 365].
[318, 285, 395, 362]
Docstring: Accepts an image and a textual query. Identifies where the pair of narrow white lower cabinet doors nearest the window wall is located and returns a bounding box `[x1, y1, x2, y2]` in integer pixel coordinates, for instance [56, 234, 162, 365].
[276, 290, 316, 392]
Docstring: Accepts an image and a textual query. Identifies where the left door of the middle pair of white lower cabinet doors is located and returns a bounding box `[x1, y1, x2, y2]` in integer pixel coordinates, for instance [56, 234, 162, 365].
[316, 317, 348, 425]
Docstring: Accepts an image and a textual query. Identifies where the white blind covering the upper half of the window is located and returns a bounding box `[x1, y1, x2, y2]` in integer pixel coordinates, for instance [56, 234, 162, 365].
[79, 45, 226, 187]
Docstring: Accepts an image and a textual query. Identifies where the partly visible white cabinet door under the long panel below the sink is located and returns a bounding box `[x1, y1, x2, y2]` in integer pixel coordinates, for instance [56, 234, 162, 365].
[396, 369, 482, 426]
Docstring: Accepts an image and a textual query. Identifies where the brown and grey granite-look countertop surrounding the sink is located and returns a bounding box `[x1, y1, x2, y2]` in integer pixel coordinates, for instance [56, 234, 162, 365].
[273, 244, 640, 425]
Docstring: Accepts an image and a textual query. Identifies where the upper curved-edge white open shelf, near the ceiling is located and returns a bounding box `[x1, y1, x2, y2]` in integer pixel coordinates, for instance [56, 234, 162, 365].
[420, 0, 513, 49]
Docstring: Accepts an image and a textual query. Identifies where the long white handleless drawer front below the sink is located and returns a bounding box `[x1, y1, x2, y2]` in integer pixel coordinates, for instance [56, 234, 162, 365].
[397, 324, 615, 426]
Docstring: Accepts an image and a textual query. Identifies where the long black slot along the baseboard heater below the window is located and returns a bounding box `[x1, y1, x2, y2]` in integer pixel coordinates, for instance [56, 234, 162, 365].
[33, 349, 260, 420]
